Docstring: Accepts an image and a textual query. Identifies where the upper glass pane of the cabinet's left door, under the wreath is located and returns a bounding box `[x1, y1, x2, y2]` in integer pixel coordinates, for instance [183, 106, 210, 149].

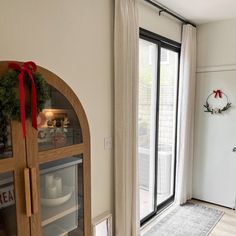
[0, 122, 13, 159]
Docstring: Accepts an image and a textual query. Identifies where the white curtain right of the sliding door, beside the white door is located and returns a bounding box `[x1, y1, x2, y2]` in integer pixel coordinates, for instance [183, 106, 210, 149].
[176, 25, 196, 204]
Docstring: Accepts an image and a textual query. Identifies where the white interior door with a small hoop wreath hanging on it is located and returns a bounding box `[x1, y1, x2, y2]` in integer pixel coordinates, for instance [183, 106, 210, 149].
[193, 71, 236, 208]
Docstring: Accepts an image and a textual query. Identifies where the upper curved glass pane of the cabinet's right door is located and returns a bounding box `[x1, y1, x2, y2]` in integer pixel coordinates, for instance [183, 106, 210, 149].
[38, 86, 82, 151]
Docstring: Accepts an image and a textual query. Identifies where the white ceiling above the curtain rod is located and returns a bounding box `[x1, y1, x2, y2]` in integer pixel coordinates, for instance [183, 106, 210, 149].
[156, 0, 236, 24]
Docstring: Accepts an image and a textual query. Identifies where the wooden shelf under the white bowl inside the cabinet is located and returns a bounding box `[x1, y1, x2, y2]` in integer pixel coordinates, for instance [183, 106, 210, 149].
[42, 195, 81, 226]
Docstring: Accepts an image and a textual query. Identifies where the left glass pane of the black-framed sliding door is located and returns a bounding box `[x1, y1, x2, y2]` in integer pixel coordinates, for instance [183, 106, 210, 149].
[138, 40, 157, 219]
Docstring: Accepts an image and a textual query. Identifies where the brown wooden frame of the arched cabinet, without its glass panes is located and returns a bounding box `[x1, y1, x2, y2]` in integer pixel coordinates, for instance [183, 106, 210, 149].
[0, 61, 91, 236]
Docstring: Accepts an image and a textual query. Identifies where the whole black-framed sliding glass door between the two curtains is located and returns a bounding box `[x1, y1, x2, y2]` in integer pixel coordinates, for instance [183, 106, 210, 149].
[138, 30, 180, 223]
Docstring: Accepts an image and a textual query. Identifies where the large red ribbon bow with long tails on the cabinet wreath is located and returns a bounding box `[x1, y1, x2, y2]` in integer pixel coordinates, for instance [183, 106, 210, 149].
[8, 61, 37, 138]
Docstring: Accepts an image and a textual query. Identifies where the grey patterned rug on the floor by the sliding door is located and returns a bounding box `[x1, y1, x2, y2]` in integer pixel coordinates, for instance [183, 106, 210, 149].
[143, 203, 224, 236]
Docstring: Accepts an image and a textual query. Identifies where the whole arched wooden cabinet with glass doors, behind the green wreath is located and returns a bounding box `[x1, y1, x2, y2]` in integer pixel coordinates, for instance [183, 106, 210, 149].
[0, 62, 91, 236]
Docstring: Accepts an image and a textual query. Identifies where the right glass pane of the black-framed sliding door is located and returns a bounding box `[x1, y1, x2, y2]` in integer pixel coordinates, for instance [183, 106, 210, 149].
[157, 48, 178, 205]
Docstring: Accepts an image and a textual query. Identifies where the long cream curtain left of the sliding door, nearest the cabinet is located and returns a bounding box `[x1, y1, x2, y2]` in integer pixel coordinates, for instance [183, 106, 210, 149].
[114, 0, 139, 236]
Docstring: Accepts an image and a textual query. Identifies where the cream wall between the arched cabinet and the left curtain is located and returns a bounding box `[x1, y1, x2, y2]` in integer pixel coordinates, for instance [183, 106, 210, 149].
[0, 0, 113, 216]
